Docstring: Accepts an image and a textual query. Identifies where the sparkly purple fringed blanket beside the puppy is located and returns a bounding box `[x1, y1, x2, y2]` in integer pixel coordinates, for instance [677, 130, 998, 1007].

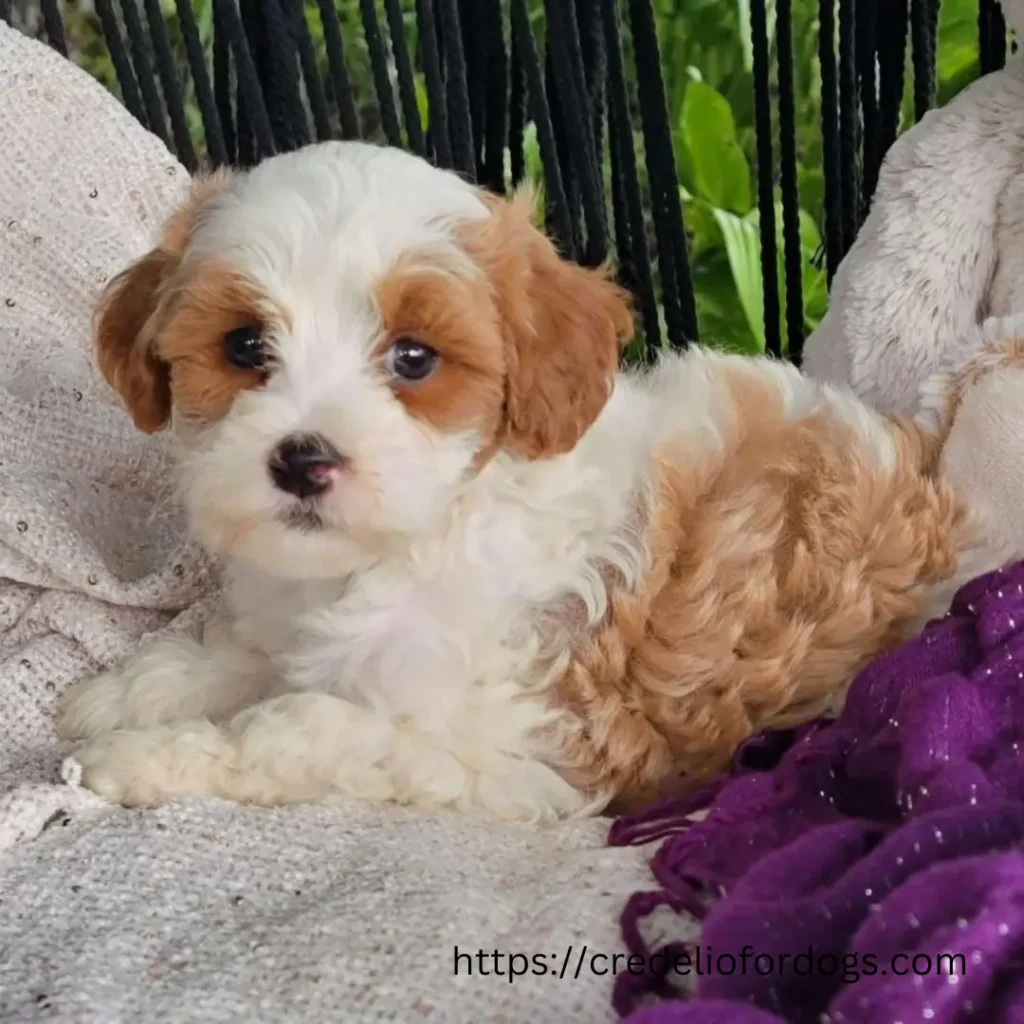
[610, 563, 1024, 1024]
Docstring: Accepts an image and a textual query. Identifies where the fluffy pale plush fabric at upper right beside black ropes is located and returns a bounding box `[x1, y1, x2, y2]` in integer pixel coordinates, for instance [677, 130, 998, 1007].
[803, 0, 1024, 415]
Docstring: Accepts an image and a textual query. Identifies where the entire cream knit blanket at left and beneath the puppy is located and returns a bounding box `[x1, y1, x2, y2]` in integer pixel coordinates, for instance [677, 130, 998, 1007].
[0, 26, 671, 1024]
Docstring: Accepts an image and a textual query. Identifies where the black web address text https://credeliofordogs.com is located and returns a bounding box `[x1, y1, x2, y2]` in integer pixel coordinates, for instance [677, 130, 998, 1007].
[454, 944, 968, 985]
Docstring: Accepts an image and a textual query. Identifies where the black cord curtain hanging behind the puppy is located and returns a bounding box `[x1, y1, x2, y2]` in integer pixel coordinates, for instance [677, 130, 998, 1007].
[0, 0, 1007, 360]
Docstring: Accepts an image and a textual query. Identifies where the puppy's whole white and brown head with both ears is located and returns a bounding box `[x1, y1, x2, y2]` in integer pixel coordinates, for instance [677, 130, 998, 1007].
[95, 142, 632, 579]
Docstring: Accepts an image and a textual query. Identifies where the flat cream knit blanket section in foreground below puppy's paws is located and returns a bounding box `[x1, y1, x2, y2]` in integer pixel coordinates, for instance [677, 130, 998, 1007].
[0, 802, 663, 1024]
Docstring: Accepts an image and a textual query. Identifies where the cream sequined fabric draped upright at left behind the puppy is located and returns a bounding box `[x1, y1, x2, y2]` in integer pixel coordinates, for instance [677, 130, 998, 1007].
[0, 25, 203, 849]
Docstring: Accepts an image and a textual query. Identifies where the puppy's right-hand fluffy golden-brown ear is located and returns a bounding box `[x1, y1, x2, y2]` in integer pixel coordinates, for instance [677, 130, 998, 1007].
[468, 194, 634, 459]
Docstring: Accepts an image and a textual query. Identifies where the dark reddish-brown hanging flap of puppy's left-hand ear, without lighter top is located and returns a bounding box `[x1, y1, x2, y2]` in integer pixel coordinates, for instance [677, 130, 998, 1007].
[93, 249, 178, 433]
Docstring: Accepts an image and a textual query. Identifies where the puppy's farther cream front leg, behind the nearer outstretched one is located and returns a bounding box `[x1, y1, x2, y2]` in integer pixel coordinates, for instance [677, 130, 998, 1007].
[56, 626, 272, 739]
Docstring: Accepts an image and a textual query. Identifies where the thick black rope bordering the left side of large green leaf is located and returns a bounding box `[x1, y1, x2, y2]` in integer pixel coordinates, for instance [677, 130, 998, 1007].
[630, 0, 698, 347]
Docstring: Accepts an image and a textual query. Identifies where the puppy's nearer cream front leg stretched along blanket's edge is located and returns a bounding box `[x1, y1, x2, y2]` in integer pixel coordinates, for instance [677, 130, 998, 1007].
[68, 692, 586, 820]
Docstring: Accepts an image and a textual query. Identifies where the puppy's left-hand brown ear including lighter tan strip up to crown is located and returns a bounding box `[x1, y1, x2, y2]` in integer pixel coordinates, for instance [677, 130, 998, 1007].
[93, 171, 233, 433]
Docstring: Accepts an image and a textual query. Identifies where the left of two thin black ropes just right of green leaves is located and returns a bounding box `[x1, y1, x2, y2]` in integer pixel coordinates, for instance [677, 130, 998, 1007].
[751, 0, 778, 355]
